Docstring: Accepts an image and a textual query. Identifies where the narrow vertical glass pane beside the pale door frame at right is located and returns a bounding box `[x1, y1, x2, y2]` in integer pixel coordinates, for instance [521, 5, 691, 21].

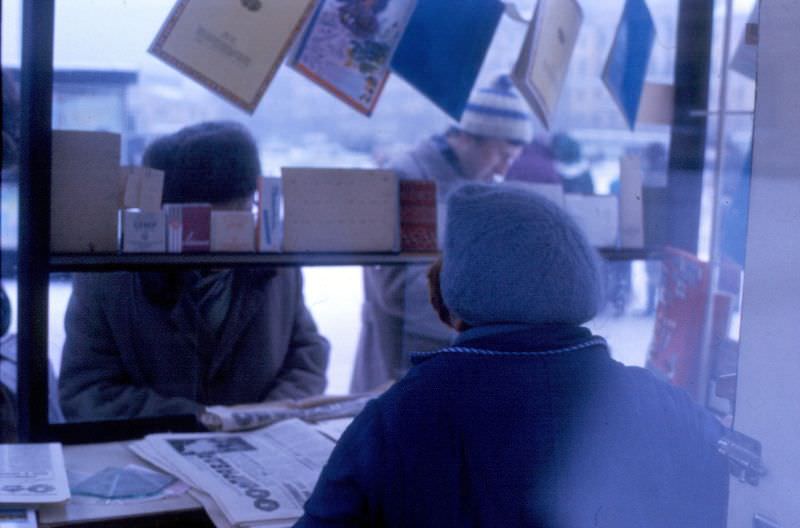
[700, 1, 756, 421]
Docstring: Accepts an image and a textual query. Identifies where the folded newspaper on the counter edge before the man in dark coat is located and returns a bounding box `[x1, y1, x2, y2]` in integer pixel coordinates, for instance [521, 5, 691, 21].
[200, 388, 383, 431]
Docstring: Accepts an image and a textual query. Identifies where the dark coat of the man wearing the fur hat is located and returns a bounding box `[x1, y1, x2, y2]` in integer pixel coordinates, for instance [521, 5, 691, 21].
[59, 268, 330, 419]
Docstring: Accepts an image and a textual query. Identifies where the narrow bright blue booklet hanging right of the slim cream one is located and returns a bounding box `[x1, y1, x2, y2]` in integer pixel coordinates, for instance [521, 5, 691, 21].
[603, 0, 656, 130]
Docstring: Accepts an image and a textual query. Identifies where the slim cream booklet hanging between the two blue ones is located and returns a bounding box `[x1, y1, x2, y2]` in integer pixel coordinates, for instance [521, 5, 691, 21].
[511, 0, 583, 129]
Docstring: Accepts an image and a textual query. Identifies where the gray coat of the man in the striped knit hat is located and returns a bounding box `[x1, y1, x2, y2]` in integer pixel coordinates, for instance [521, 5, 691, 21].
[350, 136, 467, 392]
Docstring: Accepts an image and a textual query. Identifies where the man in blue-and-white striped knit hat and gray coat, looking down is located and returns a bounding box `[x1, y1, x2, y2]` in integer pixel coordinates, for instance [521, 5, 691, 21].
[350, 75, 533, 392]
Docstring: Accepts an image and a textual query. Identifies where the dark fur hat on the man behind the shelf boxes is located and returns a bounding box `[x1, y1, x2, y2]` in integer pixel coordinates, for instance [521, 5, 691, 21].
[143, 121, 261, 203]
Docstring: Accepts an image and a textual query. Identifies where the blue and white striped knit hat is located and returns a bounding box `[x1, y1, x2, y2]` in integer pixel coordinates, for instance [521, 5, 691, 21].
[458, 75, 533, 144]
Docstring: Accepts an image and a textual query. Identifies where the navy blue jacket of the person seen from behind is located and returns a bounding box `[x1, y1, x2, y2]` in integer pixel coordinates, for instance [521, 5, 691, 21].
[296, 325, 728, 528]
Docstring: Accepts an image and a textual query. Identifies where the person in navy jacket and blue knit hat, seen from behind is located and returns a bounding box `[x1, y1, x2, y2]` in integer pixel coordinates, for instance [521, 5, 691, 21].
[295, 183, 728, 528]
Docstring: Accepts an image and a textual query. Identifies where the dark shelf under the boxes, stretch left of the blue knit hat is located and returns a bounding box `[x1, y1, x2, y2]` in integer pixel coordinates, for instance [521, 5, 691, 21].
[50, 253, 439, 271]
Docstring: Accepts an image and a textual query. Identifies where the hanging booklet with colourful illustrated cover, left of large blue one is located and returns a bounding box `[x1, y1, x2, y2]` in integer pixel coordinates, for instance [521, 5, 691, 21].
[290, 0, 416, 115]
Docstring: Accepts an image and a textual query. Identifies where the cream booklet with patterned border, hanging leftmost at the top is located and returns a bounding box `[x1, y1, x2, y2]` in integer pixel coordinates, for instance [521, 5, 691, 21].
[149, 0, 314, 113]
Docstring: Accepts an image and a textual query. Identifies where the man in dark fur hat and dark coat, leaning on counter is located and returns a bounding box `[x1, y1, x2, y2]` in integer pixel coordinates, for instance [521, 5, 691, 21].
[59, 122, 330, 420]
